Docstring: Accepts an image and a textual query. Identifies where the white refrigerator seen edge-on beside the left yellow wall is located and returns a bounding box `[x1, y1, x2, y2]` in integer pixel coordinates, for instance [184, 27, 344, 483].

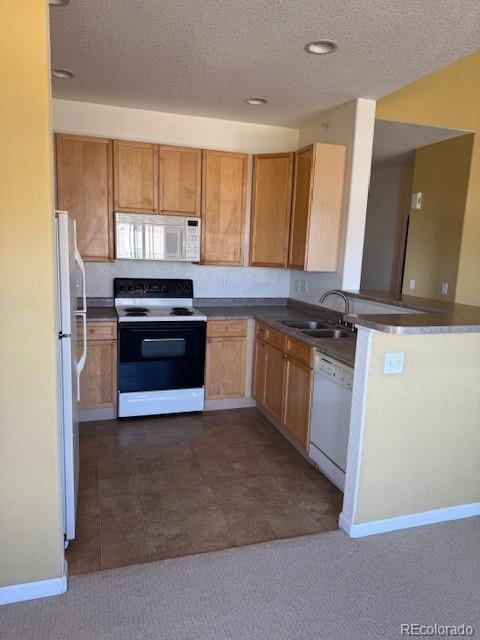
[55, 211, 87, 544]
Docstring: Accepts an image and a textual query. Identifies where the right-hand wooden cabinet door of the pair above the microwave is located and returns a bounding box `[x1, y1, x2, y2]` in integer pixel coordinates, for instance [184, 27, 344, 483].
[159, 145, 202, 216]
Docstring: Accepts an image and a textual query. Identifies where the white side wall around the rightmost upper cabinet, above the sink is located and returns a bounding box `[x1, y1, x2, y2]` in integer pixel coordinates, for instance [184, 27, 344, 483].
[290, 98, 375, 304]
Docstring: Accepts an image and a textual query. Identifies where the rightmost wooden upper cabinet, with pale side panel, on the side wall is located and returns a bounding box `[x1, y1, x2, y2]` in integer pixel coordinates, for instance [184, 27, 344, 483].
[288, 143, 346, 271]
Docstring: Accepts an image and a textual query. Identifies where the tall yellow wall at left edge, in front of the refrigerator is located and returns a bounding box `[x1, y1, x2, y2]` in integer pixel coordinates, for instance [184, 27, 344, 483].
[0, 0, 63, 586]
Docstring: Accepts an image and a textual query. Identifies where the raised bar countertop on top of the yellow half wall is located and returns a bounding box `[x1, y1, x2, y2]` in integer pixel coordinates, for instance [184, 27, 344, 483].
[344, 290, 480, 334]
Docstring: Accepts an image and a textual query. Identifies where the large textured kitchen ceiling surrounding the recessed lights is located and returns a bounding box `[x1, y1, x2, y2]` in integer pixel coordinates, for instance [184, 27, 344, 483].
[50, 0, 480, 126]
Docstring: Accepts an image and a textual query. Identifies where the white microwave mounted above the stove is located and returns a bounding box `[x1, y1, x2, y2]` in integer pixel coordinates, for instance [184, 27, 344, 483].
[115, 213, 200, 262]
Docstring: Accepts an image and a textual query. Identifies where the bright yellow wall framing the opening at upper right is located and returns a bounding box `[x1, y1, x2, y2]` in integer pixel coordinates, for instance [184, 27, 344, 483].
[377, 53, 480, 305]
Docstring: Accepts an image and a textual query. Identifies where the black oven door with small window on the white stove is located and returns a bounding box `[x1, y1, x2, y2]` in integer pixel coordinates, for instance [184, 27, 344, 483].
[118, 321, 206, 393]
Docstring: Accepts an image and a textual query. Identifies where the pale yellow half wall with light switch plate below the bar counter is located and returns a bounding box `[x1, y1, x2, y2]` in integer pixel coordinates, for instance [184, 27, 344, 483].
[354, 331, 480, 524]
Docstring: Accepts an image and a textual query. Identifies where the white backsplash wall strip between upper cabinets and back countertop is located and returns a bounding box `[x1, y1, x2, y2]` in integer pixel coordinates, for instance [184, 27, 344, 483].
[85, 260, 290, 298]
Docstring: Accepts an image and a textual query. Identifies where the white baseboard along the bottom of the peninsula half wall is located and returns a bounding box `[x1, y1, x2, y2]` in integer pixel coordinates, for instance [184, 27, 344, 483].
[338, 502, 480, 538]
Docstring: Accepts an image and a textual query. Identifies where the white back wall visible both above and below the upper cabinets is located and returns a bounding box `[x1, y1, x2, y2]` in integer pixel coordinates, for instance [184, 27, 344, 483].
[53, 100, 299, 298]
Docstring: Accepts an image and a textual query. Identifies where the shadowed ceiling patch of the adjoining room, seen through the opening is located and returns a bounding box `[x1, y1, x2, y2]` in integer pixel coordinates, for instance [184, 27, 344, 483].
[372, 120, 468, 167]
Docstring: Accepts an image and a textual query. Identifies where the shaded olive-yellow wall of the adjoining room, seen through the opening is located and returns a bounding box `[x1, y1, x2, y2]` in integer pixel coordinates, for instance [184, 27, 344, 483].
[403, 134, 473, 301]
